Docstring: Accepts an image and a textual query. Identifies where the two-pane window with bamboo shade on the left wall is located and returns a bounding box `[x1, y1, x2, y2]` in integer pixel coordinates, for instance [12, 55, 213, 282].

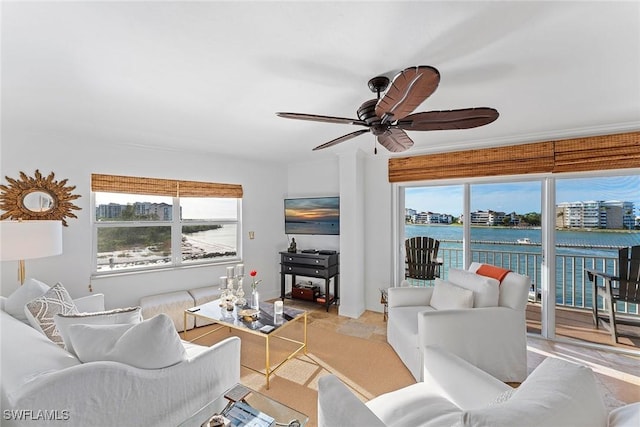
[91, 174, 242, 274]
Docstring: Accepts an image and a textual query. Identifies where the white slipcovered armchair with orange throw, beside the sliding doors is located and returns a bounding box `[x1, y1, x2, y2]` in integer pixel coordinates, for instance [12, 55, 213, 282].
[387, 262, 530, 382]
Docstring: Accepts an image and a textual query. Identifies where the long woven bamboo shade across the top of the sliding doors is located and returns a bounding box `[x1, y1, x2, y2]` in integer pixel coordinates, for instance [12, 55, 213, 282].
[389, 132, 640, 182]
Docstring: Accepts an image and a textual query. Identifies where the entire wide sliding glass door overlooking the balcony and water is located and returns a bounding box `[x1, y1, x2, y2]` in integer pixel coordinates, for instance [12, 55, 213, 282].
[398, 171, 640, 349]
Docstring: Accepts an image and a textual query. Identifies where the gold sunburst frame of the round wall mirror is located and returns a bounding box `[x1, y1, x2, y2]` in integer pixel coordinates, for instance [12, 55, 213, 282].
[0, 169, 81, 227]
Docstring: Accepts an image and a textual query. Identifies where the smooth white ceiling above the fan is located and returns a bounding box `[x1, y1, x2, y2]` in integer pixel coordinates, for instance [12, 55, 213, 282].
[1, 1, 640, 161]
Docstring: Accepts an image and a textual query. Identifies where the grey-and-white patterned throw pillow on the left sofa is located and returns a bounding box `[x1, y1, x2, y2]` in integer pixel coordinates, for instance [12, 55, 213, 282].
[24, 283, 78, 347]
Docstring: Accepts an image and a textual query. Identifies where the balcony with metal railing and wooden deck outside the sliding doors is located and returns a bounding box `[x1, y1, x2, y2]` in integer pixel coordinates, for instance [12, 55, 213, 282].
[414, 247, 640, 350]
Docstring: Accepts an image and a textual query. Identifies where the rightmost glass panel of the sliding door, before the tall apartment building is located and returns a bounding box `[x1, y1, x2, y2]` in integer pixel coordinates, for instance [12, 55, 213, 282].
[555, 175, 640, 348]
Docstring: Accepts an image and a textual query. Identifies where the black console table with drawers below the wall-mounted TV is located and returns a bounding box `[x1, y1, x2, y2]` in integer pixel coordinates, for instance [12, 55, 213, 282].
[280, 252, 340, 311]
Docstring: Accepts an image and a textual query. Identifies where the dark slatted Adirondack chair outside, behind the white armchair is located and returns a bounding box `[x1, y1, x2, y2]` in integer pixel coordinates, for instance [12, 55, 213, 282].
[405, 236, 442, 281]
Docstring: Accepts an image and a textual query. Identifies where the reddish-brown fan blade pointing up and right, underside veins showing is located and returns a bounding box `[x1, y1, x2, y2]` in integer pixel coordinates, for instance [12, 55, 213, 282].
[376, 65, 440, 123]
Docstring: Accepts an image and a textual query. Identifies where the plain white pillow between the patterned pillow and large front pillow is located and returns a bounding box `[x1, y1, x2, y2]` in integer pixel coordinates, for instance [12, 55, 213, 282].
[54, 307, 142, 354]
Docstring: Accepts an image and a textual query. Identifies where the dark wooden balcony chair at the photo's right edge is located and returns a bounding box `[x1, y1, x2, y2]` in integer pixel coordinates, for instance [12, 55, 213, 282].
[586, 246, 640, 343]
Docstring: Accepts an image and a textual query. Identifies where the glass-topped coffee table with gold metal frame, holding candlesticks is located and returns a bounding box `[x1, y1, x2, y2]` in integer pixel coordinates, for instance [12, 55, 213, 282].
[184, 299, 307, 390]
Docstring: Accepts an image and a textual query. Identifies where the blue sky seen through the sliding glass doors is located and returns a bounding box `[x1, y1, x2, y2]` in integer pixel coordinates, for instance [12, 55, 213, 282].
[405, 175, 640, 216]
